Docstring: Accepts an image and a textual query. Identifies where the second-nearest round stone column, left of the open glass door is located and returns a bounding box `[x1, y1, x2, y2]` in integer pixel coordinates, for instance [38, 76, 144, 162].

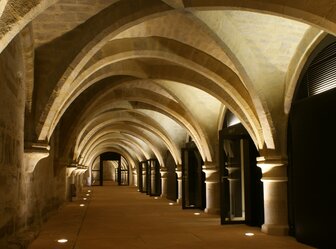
[203, 162, 220, 214]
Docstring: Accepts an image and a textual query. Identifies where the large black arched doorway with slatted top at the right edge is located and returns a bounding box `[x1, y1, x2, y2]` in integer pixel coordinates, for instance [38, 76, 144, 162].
[288, 36, 336, 248]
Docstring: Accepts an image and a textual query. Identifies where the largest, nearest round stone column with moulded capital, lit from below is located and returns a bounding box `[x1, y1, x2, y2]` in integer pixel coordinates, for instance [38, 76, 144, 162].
[257, 157, 289, 235]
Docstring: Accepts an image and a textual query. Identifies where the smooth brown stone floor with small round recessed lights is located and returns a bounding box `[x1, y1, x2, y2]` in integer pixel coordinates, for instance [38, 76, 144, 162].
[29, 181, 311, 249]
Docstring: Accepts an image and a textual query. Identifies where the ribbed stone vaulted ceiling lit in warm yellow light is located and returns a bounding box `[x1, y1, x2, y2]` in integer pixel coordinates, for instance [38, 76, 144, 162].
[0, 0, 330, 169]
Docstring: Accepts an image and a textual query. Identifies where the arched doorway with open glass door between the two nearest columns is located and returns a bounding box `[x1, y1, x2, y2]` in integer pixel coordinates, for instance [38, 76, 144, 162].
[219, 111, 264, 226]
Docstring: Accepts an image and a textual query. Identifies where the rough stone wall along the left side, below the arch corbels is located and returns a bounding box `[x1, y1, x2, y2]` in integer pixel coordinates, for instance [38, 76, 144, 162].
[0, 36, 65, 248]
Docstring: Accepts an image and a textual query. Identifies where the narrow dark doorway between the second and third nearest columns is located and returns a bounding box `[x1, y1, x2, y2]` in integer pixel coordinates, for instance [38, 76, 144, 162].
[182, 141, 206, 210]
